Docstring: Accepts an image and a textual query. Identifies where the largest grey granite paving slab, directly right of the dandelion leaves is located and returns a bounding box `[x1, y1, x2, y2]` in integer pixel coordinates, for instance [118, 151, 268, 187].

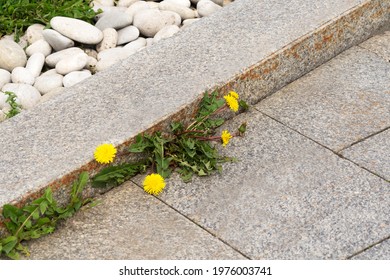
[130, 109, 390, 259]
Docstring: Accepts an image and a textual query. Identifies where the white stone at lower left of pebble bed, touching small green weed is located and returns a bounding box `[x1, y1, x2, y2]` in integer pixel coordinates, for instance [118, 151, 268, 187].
[2, 83, 41, 109]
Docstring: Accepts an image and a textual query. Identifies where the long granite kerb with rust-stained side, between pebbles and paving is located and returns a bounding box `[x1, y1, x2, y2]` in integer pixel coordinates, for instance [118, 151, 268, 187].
[0, 0, 390, 236]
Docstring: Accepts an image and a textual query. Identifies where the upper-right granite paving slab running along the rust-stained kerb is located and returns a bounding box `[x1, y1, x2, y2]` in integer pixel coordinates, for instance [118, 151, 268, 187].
[259, 47, 390, 152]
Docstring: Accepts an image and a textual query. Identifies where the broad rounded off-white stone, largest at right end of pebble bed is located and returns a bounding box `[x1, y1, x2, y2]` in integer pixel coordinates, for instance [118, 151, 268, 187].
[133, 9, 176, 37]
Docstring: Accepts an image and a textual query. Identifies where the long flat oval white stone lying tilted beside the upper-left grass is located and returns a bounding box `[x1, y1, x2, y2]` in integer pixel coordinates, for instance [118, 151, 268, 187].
[50, 16, 103, 45]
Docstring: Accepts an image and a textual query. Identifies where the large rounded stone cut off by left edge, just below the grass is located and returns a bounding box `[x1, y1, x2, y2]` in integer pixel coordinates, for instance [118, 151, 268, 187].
[0, 39, 27, 72]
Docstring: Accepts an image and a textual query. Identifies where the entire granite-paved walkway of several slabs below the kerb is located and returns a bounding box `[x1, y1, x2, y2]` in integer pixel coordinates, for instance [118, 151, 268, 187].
[25, 27, 390, 259]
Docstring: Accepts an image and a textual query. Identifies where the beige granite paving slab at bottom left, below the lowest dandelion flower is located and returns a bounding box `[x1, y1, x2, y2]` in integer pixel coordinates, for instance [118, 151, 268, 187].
[24, 182, 245, 260]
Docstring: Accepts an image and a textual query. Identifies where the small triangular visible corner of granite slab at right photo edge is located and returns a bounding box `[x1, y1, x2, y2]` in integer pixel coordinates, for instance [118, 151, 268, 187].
[341, 129, 390, 181]
